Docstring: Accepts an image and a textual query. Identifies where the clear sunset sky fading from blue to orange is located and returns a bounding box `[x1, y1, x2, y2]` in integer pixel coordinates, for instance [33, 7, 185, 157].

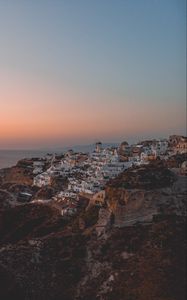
[0, 0, 186, 149]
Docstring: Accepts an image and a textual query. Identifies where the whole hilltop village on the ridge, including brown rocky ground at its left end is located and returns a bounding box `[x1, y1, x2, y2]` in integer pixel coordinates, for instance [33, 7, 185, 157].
[0, 135, 187, 216]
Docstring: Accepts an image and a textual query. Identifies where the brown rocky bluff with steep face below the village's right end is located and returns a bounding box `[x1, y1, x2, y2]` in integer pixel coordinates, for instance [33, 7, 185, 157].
[106, 166, 187, 226]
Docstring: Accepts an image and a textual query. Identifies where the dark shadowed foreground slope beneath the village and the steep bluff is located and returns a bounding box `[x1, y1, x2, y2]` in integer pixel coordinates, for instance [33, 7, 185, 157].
[0, 199, 187, 300]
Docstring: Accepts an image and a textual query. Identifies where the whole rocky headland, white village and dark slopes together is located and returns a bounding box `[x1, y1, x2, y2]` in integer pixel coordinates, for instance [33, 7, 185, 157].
[0, 135, 187, 300]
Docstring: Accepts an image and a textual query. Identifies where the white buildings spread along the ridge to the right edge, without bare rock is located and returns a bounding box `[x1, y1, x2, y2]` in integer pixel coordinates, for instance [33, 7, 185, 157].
[33, 136, 187, 215]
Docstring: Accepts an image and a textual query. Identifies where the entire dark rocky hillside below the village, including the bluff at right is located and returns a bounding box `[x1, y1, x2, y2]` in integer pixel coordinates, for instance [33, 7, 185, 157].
[0, 165, 187, 300]
